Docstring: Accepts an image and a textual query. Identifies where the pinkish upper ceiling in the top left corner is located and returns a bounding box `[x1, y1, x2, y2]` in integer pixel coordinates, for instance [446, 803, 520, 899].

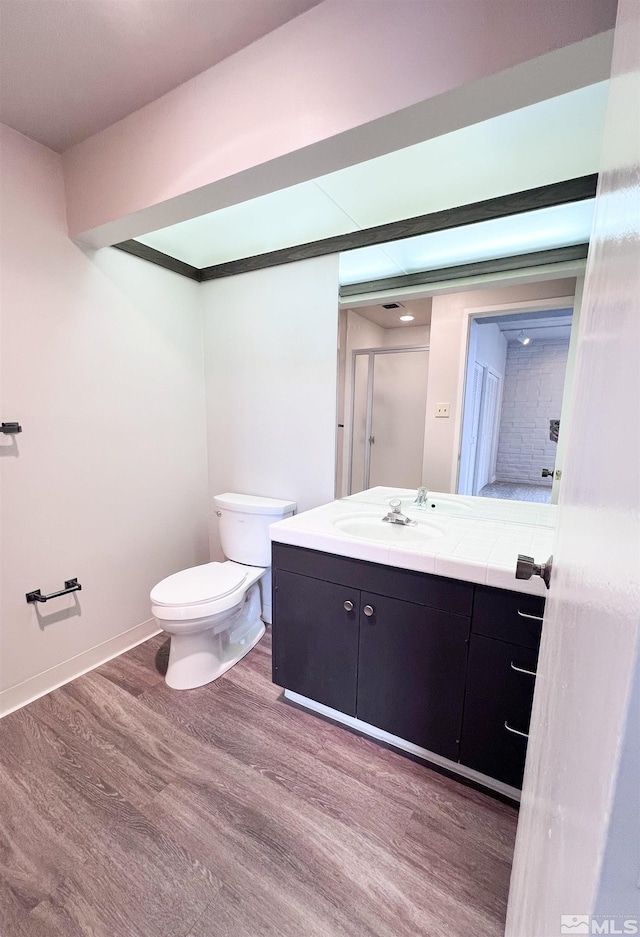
[0, 0, 320, 152]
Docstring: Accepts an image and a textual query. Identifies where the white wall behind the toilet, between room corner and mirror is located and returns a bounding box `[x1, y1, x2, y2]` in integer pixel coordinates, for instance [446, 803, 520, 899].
[201, 255, 338, 557]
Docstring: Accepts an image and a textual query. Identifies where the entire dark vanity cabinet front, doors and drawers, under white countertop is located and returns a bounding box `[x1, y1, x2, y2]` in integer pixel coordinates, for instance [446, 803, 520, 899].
[273, 543, 544, 787]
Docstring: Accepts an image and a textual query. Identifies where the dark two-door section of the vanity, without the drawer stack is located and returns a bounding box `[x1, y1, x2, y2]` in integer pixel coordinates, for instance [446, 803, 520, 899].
[273, 544, 473, 761]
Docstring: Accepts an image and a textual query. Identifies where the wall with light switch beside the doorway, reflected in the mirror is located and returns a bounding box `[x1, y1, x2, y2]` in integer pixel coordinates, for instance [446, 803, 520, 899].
[423, 279, 575, 491]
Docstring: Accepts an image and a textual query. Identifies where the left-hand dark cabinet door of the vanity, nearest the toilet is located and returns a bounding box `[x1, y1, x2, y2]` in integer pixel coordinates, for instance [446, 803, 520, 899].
[273, 569, 360, 716]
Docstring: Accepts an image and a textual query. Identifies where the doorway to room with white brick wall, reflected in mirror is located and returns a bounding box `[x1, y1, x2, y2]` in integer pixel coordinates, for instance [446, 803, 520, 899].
[458, 308, 572, 503]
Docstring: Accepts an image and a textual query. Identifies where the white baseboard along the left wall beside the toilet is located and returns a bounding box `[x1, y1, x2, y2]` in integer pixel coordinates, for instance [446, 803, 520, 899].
[0, 618, 161, 718]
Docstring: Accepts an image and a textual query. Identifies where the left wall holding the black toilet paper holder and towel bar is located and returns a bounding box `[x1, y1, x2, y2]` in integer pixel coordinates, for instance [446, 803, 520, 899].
[0, 122, 208, 711]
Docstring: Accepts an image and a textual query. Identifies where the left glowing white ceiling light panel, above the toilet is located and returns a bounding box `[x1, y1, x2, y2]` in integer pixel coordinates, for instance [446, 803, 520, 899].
[136, 182, 358, 267]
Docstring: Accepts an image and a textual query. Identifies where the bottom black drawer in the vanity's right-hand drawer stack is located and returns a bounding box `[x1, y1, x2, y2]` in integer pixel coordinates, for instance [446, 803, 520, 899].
[460, 692, 528, 788]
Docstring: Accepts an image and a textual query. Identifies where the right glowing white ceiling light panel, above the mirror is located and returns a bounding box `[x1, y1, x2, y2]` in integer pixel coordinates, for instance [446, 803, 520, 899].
[316, 82, 608, 228]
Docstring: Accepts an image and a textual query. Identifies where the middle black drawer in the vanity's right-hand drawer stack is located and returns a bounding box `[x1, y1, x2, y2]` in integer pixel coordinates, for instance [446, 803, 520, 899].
[467, 634, 538, 732]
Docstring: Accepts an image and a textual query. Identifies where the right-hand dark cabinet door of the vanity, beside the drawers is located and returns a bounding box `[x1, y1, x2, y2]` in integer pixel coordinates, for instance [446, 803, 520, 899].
[357, 592, 469, 761]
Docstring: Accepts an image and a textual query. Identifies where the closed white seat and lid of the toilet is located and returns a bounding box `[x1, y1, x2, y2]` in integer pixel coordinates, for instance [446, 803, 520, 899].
[151, 560, 266, 622]
